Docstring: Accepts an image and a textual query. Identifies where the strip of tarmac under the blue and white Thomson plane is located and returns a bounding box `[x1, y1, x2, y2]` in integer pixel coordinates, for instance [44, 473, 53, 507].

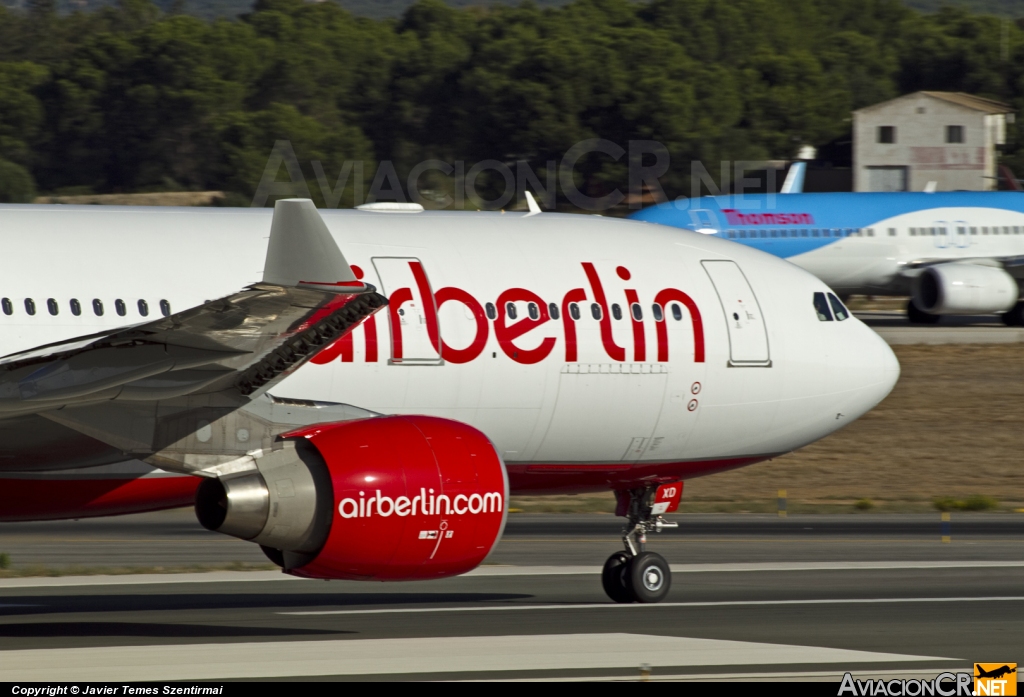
[854, 310, 1024, 344]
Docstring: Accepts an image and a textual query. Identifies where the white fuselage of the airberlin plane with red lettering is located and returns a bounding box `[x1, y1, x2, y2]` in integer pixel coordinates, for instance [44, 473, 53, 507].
[0, 206, 902, 481]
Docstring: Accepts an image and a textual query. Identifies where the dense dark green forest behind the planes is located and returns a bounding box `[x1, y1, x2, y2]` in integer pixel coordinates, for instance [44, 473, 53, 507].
[0, 0, 1024, 205]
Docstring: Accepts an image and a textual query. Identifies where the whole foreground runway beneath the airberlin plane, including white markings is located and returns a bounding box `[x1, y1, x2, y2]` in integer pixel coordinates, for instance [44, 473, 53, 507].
[0, 511, 1024, 682]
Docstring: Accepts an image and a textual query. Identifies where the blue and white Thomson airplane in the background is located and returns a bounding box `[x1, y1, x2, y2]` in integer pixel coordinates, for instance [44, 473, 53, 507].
[633, 185, 1024, 326]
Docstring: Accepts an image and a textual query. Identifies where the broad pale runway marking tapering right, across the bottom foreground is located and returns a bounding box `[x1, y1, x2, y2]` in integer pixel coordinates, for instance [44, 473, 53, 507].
[0, 634, 956, 684]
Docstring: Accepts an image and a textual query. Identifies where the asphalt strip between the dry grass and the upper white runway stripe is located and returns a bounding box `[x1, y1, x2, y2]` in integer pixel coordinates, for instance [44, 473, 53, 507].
[0, 509, 1024, 569]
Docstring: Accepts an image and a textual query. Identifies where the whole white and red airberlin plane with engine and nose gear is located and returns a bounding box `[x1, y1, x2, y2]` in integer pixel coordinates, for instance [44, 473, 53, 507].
[0, 200, 899, 602]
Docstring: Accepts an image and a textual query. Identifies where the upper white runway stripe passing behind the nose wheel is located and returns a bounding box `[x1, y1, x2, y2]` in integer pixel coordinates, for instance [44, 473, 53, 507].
[0, 561, 1024, 590]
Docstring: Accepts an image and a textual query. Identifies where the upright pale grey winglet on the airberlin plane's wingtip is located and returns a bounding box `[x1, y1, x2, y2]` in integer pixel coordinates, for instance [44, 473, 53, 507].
[263, 199, 362, 288]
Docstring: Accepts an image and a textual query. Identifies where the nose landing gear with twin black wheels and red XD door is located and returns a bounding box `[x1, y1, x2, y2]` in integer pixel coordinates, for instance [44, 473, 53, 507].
[601, 482, 683, 603]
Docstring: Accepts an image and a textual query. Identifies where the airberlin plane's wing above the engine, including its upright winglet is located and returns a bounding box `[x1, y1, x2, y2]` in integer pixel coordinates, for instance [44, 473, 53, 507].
[0, 200, 387, 419]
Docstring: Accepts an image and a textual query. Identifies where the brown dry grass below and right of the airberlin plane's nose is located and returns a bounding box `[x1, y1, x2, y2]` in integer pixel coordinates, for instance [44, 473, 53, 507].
[511, 344, 1024, 513]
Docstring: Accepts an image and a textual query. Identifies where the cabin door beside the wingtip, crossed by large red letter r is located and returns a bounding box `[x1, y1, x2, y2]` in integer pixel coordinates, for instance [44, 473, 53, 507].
[373, 257, 441, 365]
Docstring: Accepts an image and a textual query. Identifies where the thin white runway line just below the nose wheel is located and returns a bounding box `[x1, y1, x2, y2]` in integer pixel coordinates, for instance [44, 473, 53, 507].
[278, 596, 1024, 615]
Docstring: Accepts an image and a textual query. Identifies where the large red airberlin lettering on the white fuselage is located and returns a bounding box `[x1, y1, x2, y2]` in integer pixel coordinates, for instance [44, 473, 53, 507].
[312, 261, 705, 365]
